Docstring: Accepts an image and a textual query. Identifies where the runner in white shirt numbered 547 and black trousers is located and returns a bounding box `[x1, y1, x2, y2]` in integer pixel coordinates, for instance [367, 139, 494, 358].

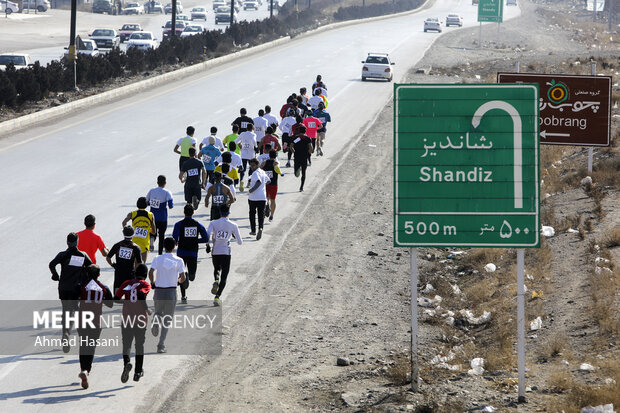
[207, 207, 243, 305]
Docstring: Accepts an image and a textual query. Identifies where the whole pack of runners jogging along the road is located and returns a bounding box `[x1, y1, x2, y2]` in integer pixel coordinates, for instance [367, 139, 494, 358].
[49, 75, 331, 388]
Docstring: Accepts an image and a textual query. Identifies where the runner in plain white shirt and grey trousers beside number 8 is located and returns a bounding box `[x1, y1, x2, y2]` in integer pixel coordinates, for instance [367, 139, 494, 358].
[149, 237, 187, 353]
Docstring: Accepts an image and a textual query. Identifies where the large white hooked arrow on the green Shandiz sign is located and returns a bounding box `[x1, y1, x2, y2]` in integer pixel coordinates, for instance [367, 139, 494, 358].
[471, 100, 523, 208]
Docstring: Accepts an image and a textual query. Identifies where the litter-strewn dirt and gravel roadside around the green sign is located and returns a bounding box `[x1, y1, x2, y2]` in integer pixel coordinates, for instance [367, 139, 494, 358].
[151, 1, 620, 412]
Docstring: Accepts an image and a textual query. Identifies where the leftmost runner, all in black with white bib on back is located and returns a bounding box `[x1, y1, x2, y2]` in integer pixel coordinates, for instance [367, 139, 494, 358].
[49, 232, 92, 353]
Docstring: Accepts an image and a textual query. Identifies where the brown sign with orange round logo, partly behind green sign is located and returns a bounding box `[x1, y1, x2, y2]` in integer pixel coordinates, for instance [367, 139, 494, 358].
[497, 73, 611, 146]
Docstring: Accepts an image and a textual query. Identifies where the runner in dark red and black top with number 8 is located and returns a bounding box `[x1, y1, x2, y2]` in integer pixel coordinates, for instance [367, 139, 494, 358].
[114, 264, 151, 383]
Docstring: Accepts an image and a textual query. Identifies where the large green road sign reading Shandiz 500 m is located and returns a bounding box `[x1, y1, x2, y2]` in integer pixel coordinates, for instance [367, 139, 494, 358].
[394, 84, 539, 247]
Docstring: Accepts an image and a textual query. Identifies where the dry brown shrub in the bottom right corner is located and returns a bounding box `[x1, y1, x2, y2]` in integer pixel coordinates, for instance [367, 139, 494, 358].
[547, 358, 620, 413]
